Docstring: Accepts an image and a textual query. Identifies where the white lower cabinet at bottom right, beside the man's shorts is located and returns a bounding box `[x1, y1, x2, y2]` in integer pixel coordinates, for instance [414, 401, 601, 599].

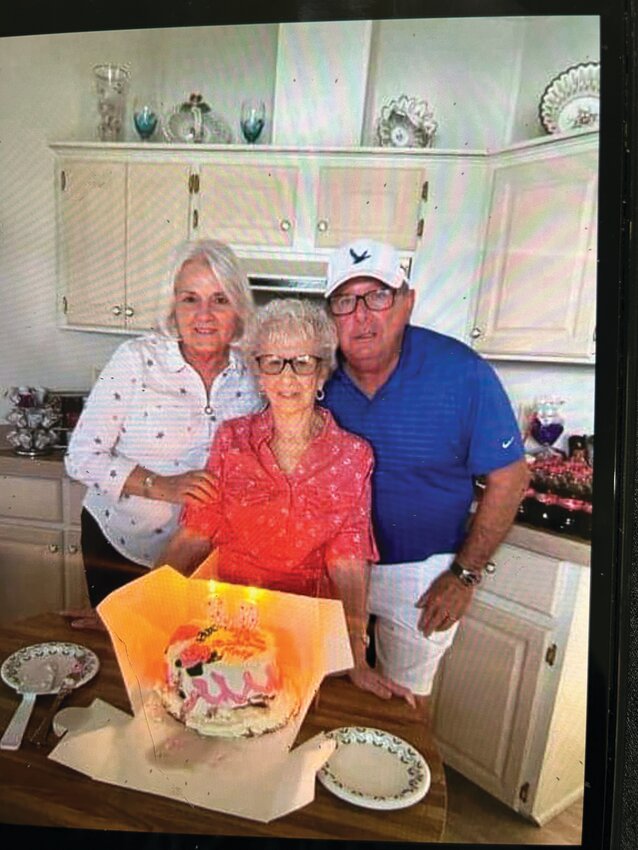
[432, 544, 589, 824]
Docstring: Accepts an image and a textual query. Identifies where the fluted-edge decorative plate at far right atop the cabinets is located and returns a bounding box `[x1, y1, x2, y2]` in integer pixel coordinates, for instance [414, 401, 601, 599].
[538, 62, 600, 133]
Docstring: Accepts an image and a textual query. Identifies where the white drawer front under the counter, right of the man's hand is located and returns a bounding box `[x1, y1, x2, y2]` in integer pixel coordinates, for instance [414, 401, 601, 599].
[478, 545, 563, 616]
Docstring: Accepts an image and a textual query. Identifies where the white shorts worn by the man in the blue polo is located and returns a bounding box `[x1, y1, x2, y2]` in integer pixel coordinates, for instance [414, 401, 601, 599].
[368, 553, 459, 696]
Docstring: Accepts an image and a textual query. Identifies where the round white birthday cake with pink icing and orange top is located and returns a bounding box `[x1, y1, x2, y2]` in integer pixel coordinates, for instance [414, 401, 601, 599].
[160, 623, 299, 738]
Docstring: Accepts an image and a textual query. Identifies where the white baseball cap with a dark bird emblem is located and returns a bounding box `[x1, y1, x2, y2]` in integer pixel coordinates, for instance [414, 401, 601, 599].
[324, 239, 407, 298]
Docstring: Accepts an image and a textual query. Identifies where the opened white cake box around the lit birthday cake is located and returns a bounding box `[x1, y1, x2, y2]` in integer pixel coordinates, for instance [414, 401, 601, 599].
[49, 566, 353, 822]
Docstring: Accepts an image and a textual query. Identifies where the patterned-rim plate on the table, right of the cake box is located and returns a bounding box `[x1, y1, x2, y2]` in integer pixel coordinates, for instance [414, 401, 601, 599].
[317, 726, 431, 809]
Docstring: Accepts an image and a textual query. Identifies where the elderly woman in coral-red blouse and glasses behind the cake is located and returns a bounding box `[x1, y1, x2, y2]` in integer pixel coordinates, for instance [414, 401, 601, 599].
[157, 299, 412, 702]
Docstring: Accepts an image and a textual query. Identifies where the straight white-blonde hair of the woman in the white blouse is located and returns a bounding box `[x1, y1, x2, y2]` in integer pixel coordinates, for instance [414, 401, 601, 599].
[157, 239, 255, 339]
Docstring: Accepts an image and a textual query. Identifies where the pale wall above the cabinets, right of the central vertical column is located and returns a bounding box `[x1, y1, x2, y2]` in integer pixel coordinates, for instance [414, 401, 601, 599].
[363, 16, 600, 150]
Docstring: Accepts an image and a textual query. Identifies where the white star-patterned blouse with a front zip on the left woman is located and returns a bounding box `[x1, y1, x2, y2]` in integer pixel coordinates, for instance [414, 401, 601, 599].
[65, 334, 262, 567]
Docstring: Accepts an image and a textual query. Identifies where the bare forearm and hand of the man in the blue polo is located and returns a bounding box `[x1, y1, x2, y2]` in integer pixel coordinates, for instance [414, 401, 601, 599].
[416, 460, 529, 637]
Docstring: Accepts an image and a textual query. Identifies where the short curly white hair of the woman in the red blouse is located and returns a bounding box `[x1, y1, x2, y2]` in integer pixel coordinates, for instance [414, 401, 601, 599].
[241, 297, 337, 377]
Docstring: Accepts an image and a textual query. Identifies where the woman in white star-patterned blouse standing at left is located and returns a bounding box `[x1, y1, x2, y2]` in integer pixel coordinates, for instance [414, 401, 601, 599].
[66, 239, 261, 612]
